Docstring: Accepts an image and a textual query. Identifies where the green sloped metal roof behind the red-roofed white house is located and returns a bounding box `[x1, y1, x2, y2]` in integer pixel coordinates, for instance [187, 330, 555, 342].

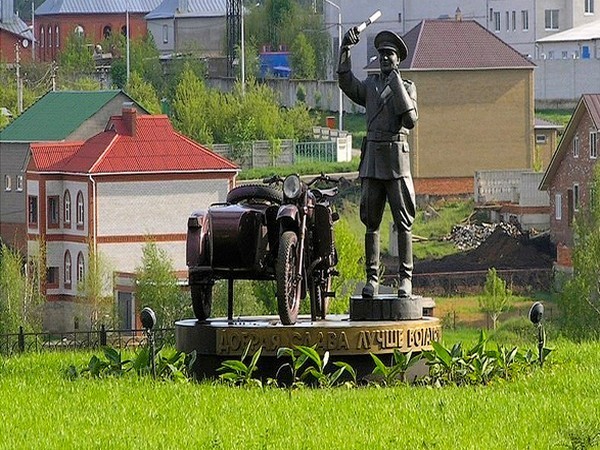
[0, 90, 126, 142]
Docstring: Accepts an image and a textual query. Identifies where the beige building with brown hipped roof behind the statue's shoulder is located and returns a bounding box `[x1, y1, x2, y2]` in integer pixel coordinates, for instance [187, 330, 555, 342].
[368, 20, 535, 186]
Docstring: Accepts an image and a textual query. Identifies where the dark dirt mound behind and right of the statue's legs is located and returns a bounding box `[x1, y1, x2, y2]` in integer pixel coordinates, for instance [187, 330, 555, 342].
[410, 227, 556, 273]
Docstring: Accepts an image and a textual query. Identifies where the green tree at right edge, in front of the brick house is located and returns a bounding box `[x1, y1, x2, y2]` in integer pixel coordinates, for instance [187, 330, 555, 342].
[559, 164, 600, 339]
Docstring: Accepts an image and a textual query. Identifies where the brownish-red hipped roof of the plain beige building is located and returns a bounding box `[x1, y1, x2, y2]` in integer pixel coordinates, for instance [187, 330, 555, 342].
[368, 20, 535, 70]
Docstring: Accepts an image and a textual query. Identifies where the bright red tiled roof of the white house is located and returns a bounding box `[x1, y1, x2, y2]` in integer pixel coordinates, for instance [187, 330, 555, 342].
[32, 115, 237, 174]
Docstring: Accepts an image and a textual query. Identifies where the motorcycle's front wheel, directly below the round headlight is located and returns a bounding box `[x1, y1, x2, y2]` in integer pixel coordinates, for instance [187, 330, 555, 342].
[276, 231, 300, 325]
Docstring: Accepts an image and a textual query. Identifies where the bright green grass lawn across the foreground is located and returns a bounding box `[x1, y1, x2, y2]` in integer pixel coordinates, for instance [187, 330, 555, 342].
[0, 333, 600, 449]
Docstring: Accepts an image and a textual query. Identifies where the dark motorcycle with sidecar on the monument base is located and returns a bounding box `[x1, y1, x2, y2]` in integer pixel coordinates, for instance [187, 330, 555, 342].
[186, 174, 339, 325]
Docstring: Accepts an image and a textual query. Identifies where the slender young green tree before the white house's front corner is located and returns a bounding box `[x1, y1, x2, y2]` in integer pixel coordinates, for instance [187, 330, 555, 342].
[77, 242, 114, 329]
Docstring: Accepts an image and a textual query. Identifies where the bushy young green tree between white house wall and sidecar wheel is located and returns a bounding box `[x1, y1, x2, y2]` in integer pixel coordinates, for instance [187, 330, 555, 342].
[135, 240, 186, 327]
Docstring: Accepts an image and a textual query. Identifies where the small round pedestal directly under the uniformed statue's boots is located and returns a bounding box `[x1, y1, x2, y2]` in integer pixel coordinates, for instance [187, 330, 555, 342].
[350, 294, 434, 320]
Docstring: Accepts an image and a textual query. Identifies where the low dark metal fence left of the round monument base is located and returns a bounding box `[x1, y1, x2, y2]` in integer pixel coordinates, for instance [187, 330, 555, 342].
[0, 326, 175, 355]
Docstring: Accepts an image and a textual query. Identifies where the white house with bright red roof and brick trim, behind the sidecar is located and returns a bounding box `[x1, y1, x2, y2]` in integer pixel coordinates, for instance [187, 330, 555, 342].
[26, 105, 237, 331]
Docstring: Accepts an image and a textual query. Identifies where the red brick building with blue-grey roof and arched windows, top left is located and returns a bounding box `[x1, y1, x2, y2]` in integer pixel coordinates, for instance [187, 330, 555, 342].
[35, 0, 160, 61]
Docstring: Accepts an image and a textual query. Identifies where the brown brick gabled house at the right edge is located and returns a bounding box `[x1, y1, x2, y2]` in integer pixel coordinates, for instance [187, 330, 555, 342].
[540, 94, 600, 270]
